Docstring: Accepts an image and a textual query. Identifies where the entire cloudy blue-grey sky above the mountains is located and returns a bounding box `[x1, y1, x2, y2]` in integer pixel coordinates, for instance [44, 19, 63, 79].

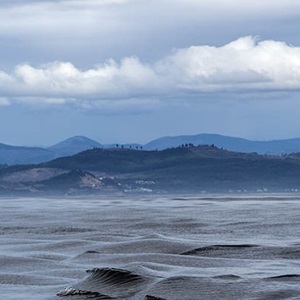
[0, 0, 300, 146]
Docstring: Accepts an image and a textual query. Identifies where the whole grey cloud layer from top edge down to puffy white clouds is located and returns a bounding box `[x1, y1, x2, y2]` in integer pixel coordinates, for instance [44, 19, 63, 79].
[0, 0, 300, 67]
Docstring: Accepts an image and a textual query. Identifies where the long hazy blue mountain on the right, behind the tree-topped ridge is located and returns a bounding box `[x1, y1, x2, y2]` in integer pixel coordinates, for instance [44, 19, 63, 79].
[144, 134, 300, 155]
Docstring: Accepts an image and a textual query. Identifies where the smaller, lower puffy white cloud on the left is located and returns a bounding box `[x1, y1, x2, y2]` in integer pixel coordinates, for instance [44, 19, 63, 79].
[11, 57, 156, 98]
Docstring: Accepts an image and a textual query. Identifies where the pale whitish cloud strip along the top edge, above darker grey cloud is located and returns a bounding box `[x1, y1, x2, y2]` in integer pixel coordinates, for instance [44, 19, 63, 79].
[0, 0, 300, 41]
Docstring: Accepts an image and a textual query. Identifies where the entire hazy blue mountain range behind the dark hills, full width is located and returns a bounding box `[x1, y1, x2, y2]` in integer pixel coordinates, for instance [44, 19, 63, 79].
[0, 134, 300, 165]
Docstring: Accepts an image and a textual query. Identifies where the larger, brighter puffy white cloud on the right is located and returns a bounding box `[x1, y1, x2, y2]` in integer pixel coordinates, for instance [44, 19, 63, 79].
[157, 37, 300, 91]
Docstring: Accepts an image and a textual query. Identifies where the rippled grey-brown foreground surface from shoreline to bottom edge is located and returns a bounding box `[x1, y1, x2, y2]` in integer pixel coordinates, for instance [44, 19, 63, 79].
[0, 195, 300, 300]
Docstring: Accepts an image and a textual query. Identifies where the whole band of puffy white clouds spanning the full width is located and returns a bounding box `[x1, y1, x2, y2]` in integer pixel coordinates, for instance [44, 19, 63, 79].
[0, 36, 300, 109]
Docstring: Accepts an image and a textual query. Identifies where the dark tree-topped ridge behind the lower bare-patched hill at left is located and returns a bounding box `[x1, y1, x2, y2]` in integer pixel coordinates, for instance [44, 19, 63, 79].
[39, 146, 300, 192]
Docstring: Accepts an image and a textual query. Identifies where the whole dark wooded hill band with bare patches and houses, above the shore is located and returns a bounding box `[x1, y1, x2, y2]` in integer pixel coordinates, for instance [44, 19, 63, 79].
[0, 144, 300, 194]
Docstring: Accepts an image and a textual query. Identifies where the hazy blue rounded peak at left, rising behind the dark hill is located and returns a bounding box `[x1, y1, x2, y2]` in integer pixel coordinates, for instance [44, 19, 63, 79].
[48, 136, 102, 156]
